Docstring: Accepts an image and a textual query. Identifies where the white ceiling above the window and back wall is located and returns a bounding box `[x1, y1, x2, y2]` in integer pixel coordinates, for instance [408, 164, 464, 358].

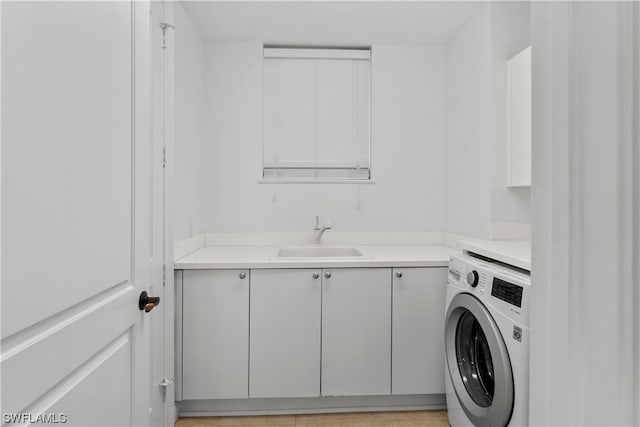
[181, 0, 482, 46]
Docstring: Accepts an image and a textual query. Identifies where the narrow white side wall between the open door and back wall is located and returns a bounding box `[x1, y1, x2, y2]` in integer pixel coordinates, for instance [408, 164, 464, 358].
[173, 3, 207, 240]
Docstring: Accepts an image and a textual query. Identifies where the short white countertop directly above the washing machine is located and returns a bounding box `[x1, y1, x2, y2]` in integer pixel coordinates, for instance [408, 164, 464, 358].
[460, 240, 531, 271]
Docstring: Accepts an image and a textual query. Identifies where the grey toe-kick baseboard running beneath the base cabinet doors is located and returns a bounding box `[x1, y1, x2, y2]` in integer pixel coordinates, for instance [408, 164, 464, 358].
[176, 394, 447, 417]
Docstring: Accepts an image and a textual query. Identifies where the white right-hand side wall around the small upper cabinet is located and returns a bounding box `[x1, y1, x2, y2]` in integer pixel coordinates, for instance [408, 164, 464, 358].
[445, 2, 531, 239]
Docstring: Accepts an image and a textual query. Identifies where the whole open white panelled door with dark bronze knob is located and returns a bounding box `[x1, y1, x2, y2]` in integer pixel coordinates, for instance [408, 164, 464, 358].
[0, 2, 155, 426]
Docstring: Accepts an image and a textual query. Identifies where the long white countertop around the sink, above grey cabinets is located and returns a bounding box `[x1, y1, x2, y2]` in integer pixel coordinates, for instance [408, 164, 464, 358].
[174, 245, 457, 270]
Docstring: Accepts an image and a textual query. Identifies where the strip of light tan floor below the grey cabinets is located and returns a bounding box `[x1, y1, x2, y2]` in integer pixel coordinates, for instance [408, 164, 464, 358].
[176, 411, 449, 427]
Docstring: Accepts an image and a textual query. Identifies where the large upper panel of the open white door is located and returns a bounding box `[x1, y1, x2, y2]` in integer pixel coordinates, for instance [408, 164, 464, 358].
[2, 2, 132, 338]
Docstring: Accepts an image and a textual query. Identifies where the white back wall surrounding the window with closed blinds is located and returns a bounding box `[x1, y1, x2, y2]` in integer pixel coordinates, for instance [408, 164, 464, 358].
[203, 42, 445, 232]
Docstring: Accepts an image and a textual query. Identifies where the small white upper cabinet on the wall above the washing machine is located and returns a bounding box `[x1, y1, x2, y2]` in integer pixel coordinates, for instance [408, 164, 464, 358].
[507, 47, 531, 187]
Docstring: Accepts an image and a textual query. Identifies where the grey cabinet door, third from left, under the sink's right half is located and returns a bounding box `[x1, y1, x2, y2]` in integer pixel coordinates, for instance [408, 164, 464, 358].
[322, 268, 391, 396]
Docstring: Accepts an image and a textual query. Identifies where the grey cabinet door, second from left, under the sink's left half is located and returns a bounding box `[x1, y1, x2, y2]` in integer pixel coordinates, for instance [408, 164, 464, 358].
[249, 269, 322, 397]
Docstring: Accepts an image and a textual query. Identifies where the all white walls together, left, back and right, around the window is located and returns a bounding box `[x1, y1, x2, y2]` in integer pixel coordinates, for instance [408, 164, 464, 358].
[175, 2, 531, 240]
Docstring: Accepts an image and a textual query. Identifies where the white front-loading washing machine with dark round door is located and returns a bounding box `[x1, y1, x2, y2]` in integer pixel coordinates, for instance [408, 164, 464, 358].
[445, 254, 531, 427]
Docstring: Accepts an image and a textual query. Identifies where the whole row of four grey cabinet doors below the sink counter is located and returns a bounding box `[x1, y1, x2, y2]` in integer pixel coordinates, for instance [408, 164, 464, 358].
[182, 267, 447, 400]
